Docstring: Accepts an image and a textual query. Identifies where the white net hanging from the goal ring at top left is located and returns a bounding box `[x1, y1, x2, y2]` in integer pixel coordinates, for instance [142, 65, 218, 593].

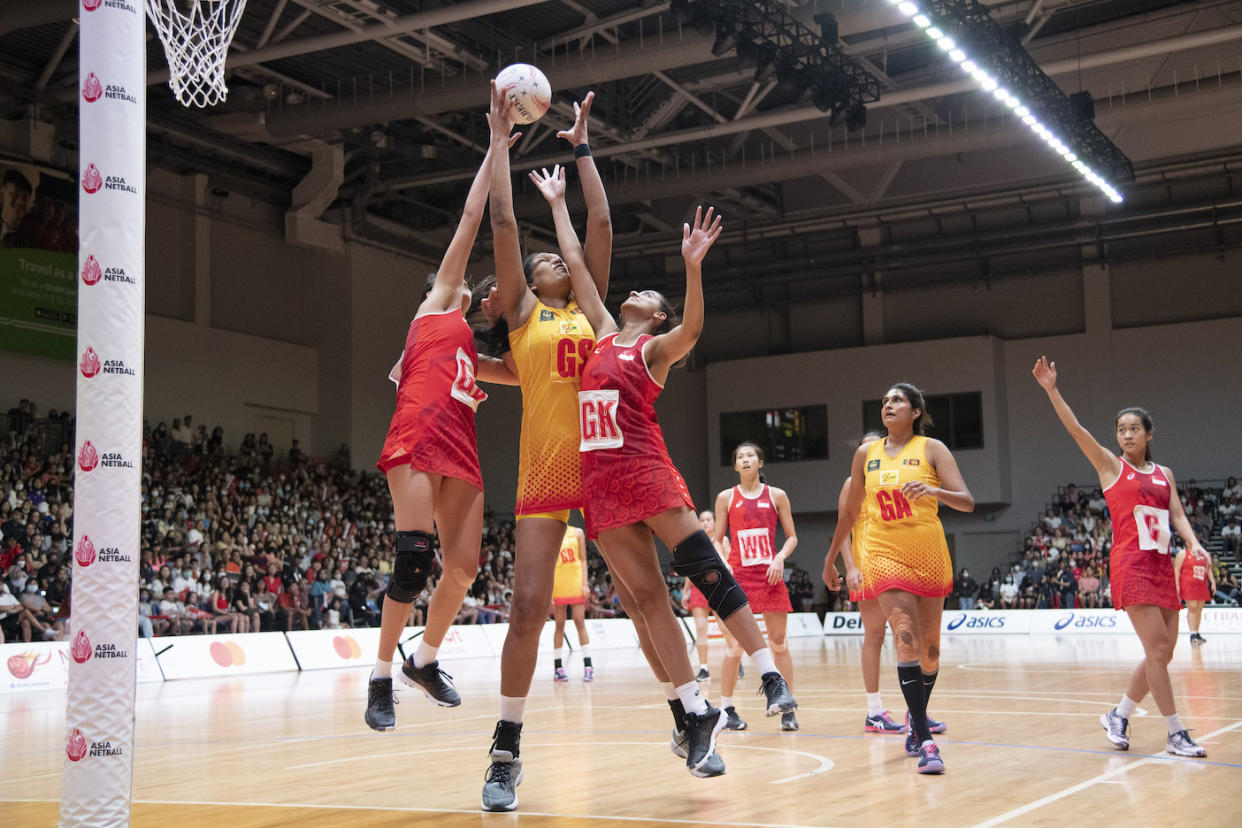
[145, 0, 246, 108]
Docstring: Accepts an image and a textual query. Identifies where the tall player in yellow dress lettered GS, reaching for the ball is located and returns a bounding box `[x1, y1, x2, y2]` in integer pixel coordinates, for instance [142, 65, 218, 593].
[483, 81, 612, 811]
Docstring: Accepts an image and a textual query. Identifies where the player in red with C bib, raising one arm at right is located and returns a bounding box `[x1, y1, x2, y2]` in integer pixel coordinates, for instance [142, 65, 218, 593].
[1032, 356, 1207, 756]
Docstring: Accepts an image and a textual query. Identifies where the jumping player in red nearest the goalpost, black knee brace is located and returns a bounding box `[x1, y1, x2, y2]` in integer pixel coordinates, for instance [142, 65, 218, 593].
[365, 137, 517, 730]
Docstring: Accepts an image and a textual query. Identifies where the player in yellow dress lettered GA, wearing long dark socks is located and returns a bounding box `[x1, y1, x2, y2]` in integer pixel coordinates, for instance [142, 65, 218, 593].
[825, 382, 975, 773]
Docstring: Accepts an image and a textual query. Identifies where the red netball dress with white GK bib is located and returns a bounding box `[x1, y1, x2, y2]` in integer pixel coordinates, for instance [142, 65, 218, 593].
[578, 334, 694, 540]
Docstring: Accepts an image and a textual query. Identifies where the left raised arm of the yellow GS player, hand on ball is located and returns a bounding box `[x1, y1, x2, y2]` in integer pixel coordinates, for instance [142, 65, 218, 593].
[487, 78, 535, 330]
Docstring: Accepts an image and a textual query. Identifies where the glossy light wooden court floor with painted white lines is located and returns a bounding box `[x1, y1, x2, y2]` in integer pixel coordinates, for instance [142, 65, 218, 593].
[0, 636, 1242, 828]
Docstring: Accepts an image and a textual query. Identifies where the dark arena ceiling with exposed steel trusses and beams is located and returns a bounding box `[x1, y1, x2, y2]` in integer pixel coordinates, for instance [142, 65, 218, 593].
[0, 0, 1242, 297]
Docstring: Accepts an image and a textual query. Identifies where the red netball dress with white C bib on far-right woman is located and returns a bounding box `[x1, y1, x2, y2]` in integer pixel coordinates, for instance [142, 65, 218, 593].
[1104, 458, 1181, 610]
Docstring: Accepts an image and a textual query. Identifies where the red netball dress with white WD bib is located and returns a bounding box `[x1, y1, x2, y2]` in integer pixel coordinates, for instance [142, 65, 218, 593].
[729, 484, 794, 612]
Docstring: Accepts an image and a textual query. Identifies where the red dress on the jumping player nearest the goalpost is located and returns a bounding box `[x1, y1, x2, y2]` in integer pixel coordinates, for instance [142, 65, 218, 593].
[376, 308, 487, 489]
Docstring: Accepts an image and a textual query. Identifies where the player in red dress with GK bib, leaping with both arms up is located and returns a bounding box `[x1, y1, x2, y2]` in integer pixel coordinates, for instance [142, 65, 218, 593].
[530, 168, 797, 776]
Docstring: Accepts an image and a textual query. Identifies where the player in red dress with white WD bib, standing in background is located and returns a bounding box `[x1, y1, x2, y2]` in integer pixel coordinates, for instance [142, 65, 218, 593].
[715, 443, 797, 730]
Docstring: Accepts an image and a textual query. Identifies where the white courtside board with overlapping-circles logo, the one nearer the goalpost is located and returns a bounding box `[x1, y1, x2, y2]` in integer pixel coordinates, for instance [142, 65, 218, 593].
[154, 633, 298, 680]
